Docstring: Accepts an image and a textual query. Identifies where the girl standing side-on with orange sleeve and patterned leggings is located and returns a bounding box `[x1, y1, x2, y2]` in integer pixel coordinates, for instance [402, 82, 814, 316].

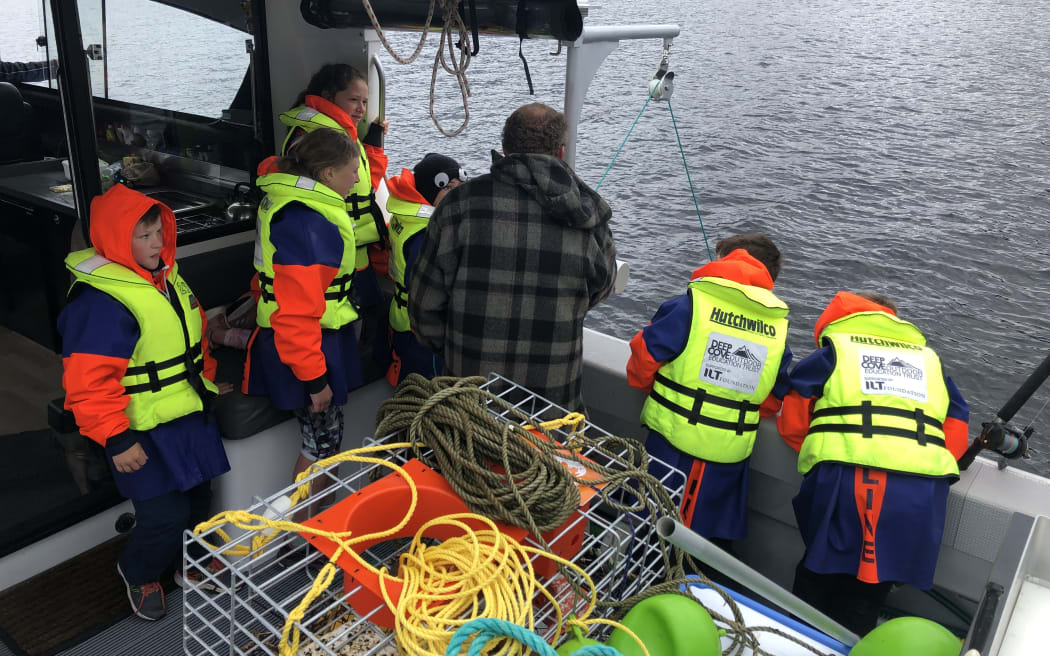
[243, 128, 361, 501]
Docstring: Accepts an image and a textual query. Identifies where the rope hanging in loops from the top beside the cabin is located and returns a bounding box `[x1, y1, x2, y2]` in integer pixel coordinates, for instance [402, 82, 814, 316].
[361, 0, 470, 136]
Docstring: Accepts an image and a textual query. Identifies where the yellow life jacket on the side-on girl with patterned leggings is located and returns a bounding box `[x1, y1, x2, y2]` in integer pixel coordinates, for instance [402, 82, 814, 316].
[255, 173, 357, 329]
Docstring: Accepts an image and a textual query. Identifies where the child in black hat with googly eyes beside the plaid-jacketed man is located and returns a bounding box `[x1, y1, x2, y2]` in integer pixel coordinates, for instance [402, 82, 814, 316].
[386, 152, 466, 385]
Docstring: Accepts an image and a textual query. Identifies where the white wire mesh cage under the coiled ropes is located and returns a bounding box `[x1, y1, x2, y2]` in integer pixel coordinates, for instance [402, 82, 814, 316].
[183, 375, 685, 656]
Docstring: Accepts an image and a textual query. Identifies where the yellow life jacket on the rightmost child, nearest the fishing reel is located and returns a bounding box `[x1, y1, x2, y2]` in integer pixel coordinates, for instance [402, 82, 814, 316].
[798, 312, 959, 478]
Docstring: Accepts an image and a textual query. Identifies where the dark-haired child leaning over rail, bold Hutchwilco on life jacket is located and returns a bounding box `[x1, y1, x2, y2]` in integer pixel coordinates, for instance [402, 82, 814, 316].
[627, 233, 792, 549]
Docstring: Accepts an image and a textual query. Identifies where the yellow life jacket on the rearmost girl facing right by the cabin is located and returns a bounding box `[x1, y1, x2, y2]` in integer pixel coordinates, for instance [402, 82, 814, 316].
[279, 105, 386, 271]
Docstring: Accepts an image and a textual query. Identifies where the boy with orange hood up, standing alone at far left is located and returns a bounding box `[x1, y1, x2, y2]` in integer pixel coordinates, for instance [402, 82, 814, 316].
[59, 185, 230, 620]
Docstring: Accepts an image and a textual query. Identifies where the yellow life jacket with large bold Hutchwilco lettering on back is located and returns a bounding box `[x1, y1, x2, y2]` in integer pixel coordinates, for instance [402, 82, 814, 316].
[642, 277, 788, 463]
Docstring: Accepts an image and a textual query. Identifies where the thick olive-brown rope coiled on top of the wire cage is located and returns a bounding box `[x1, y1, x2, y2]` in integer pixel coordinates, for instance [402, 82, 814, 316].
[376, 374, 824, 656]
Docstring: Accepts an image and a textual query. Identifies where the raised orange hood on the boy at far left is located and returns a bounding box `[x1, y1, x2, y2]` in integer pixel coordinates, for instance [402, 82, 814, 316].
[90, 185, 175, 291]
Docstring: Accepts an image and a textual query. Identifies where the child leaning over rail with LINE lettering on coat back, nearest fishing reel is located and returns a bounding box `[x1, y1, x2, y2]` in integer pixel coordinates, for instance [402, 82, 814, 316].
[777, 292, 969, 635]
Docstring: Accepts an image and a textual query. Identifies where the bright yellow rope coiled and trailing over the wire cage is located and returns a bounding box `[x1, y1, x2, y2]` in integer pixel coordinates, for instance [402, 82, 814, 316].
[193, 442, 649, 656]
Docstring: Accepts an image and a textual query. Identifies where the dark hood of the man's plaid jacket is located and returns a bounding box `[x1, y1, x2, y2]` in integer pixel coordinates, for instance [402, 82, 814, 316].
[491, 153, 612, 230]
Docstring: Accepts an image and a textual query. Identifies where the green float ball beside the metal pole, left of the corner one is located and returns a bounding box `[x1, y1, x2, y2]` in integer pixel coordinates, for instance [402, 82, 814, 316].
[606, 594, 721, 656]
